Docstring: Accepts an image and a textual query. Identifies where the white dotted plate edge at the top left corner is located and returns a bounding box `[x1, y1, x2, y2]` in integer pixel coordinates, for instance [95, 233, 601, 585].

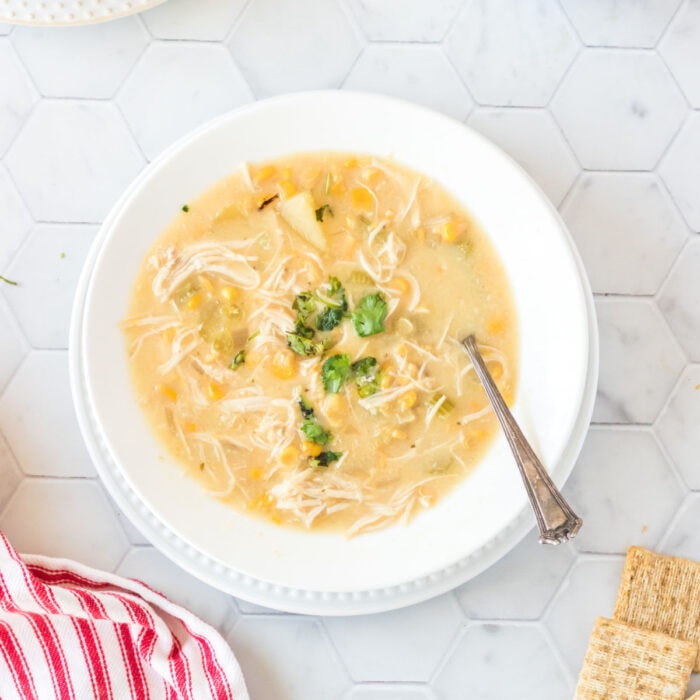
[0, 0, 165, 26]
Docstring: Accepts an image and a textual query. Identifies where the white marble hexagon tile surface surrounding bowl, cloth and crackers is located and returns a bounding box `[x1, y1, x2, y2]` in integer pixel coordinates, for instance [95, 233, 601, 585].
[0, 0, 700, 700]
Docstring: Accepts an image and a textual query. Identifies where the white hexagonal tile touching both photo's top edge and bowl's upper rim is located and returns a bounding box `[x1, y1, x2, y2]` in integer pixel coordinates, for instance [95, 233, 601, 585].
[228, 0, 362, 97]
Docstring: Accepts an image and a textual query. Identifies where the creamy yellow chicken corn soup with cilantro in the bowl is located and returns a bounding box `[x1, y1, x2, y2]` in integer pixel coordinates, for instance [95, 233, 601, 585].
[123, 153, 517, 535]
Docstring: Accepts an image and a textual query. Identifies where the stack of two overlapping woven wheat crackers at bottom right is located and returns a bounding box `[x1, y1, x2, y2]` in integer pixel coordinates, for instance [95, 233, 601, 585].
[575, 547, 700, 700]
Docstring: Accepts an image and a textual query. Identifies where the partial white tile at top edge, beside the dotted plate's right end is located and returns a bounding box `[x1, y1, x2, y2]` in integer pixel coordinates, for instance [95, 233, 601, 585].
[141, 0, 246, 41]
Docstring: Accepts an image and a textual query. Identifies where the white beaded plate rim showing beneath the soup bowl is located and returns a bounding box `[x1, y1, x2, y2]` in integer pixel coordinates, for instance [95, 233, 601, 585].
[70, 91, 598, 614]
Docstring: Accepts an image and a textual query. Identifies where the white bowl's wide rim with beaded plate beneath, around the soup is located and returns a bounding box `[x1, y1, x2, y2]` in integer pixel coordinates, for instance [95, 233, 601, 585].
[71, 92, 597, 614]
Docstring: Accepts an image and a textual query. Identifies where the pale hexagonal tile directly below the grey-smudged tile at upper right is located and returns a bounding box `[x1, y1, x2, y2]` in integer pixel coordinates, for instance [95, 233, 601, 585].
[561, 173, 688, 294]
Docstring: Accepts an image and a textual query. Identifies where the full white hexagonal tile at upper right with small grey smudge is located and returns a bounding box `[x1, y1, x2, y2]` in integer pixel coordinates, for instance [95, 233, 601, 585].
[552, 49, 687, 170]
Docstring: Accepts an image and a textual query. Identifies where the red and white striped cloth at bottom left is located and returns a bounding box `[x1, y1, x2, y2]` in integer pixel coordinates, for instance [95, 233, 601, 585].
[0, 532, 248, 700]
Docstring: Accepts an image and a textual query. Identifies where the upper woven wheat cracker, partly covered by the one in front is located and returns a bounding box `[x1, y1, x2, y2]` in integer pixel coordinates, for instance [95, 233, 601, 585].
[613, 547, 700, 671]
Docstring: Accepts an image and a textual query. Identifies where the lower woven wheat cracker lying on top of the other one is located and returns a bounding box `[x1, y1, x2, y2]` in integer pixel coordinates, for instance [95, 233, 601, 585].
[574, 617, 697, 700]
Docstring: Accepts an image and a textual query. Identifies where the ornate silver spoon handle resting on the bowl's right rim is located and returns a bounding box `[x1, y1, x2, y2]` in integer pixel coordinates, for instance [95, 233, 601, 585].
[462, 335, 583, 544]
